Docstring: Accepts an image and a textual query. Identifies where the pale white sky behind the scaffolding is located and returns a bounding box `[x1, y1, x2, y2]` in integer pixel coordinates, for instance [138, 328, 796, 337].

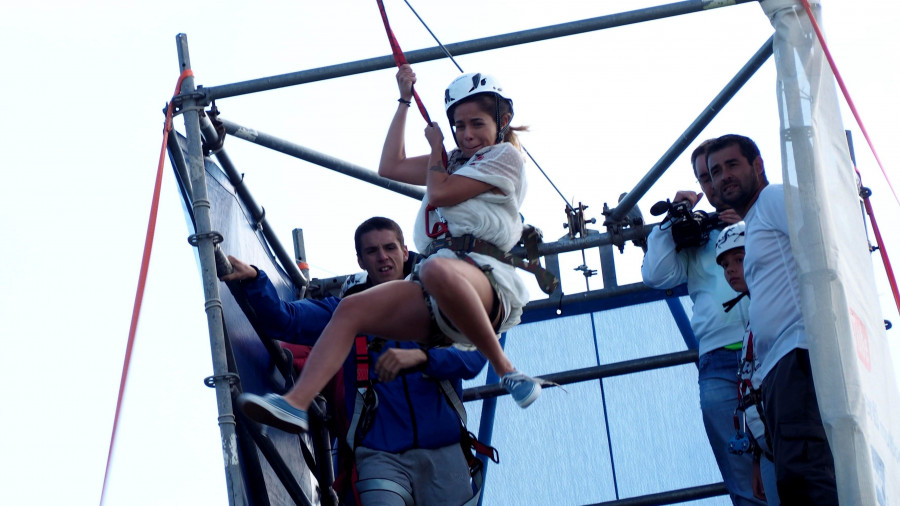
[0, 0, 900, 506]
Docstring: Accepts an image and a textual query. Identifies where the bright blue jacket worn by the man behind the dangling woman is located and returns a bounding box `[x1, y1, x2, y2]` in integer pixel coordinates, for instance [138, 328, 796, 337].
[234, 271, 486, 453]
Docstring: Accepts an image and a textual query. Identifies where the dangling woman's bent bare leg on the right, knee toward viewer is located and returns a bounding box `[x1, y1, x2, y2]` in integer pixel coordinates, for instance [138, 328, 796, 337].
[419, 257, 515, 377]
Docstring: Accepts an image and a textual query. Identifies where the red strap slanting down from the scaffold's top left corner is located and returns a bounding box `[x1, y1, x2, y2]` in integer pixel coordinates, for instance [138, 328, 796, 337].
[100, 69, 194, 505]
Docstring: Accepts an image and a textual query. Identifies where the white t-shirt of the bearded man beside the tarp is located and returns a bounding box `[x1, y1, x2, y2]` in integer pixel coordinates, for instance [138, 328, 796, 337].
[744, 184, 807, 388]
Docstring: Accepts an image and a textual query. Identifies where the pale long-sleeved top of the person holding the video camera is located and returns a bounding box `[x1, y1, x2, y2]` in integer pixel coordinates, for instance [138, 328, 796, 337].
[641, 219, 755, 355]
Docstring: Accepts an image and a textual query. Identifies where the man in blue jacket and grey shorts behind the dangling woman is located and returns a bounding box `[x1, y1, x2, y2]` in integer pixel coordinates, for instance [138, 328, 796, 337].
[222, 217, 486, 506]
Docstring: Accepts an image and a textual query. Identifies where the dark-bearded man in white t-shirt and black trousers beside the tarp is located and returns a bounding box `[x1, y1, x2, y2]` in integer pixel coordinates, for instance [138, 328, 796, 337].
[707, 135, 838, 506]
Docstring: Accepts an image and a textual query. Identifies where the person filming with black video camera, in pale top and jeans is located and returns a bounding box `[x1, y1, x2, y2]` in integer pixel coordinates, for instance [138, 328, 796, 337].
[641, 140, 766, 505]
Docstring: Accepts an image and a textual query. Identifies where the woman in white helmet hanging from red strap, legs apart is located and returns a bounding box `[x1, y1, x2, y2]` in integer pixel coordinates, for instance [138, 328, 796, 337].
[239, 65, 541, 432]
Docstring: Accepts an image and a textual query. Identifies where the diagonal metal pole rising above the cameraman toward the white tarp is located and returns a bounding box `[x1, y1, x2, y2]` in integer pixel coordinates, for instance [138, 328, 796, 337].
[606, 35, 775, 223]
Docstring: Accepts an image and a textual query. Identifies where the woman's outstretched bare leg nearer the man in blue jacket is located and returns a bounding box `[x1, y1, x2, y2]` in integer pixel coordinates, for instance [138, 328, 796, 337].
[284, 281, 432, 410]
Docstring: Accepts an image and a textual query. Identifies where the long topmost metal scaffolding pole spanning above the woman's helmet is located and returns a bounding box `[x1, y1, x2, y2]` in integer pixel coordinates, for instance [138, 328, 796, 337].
[197, 0, 756, 104]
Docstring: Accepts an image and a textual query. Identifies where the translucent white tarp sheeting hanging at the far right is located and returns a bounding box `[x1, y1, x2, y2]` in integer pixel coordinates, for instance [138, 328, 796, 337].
[761, 0, 900, 506]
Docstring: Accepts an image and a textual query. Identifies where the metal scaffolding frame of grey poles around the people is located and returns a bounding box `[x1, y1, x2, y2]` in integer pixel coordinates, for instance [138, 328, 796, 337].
[169, 0, 772, 505]
